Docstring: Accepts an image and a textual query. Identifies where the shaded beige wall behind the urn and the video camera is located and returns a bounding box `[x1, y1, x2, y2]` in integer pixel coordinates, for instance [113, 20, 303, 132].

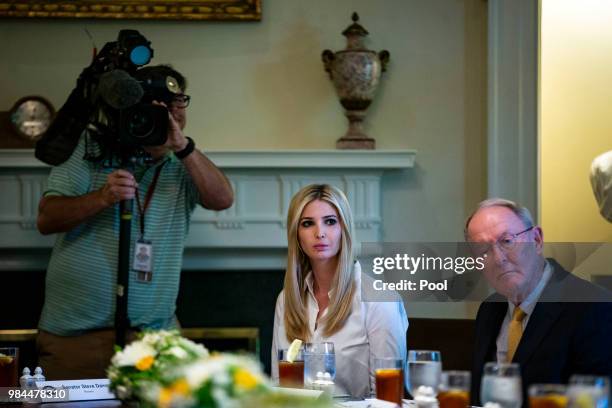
[0, 0, 487, 317]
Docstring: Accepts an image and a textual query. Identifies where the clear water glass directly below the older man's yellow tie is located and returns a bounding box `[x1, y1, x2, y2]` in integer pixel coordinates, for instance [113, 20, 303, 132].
[480, 362, 523, 408]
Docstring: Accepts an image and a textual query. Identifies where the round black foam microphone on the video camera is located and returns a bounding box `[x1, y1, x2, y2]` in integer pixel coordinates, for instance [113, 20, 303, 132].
[98, 69, 144, 109]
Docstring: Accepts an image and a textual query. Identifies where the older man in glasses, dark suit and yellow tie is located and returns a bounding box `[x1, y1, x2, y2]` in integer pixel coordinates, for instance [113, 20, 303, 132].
[465, 199, 612, 405]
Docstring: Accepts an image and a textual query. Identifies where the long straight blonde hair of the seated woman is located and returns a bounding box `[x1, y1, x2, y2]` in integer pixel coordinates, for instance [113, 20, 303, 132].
[284, 184, 356, 341]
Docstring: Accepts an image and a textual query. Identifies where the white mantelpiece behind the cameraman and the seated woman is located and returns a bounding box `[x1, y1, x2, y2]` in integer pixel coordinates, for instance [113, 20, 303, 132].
[0, 149, 416, 270]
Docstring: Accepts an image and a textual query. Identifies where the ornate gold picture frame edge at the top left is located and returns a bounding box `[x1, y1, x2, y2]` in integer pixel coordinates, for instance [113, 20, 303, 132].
[0, 0, 262, 21]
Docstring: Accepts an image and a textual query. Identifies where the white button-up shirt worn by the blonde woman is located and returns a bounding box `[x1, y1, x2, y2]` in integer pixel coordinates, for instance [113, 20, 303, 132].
[272, 262, 408, 397]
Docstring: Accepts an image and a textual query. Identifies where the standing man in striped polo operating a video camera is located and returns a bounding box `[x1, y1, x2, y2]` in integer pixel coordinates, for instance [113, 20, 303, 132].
[37, 65, 233, 380]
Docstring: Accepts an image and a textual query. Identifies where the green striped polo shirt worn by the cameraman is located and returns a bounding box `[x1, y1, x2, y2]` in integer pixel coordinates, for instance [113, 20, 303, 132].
[39, 136, 199, 336]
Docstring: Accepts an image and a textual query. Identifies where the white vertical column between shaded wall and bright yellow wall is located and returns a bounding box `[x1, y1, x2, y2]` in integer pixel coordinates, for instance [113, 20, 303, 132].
[488, 0, 539, 215]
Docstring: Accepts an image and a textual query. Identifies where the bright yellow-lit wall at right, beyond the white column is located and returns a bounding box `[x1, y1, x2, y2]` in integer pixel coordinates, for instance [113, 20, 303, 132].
[540, 0, 612, 242]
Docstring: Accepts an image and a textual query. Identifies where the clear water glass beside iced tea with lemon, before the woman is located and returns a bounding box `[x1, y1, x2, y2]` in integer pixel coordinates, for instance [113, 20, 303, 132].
[304, 342, 336, 389]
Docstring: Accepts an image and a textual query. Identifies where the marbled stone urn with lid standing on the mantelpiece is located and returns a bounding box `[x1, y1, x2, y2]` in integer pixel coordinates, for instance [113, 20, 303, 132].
[321, 13, 390, 149]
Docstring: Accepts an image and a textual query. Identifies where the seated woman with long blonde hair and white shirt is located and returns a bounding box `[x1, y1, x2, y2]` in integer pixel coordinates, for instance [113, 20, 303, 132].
[272, 184, 408, 397]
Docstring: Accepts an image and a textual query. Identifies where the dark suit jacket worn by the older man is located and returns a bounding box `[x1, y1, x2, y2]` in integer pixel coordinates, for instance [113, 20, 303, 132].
[471, 259, 612, 406]
